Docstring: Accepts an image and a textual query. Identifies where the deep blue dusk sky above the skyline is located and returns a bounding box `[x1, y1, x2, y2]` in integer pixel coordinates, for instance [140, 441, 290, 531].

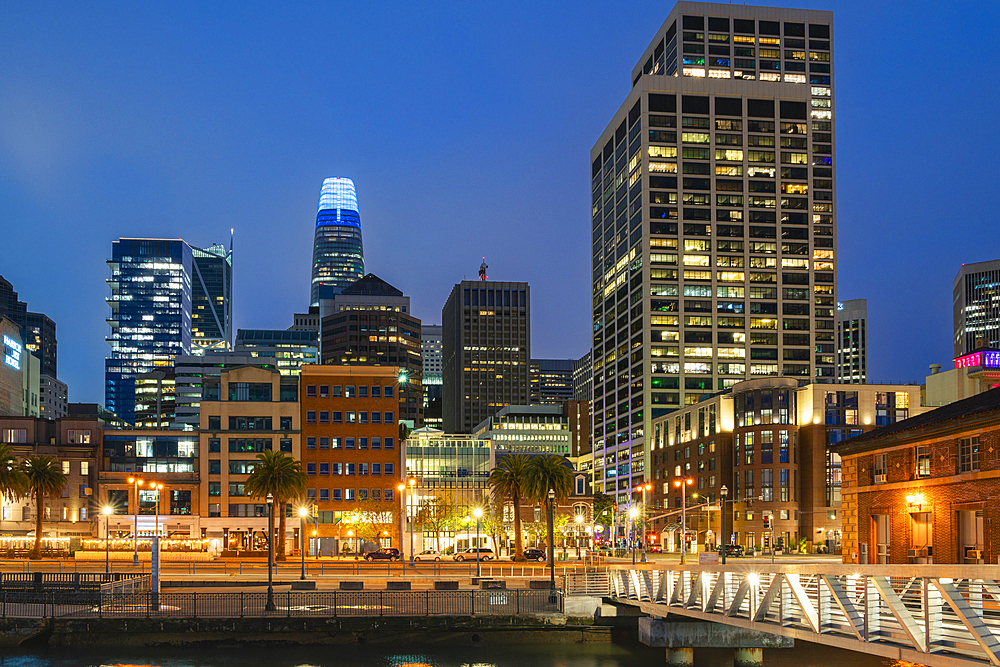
[0, 0, 1000, 403]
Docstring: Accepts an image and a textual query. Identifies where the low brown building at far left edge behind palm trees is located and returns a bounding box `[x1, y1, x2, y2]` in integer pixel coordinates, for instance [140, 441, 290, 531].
[0, 417, 102, 549]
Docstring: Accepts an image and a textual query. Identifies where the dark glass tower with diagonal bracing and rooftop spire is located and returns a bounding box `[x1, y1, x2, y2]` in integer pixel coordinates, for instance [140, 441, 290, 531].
[191, 240, 233, 354]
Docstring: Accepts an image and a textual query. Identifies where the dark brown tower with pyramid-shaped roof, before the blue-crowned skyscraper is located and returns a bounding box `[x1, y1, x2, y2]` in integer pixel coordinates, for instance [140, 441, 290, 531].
[320, 274, 424, 428]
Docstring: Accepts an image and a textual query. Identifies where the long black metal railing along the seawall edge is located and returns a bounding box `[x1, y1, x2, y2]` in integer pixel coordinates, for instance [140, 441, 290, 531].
[0, 590, 563, 619]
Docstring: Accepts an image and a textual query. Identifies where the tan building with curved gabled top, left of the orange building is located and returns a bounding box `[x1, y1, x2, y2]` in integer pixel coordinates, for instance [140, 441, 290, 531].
[196, 365, 302, 555]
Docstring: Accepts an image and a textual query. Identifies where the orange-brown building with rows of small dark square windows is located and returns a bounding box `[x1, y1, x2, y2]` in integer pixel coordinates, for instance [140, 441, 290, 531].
[299, 365, 402, 554]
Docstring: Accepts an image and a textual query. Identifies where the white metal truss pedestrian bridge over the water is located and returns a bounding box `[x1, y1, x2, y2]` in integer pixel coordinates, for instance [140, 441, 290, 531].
[608, 561, 1000, 667]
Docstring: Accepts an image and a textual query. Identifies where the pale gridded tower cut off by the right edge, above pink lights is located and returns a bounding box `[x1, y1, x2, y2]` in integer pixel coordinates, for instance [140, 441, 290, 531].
[952, 259, 1000, 357]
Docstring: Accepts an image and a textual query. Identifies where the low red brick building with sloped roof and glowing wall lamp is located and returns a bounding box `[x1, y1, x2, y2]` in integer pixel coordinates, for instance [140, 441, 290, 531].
[834, 389, 1000, 564]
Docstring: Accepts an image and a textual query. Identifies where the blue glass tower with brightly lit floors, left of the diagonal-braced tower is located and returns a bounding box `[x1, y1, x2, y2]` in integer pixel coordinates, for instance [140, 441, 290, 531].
[104, 238, 194, 424]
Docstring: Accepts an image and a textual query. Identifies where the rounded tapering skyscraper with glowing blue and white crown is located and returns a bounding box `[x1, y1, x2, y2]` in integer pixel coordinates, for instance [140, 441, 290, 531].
[310, 178, 365, 306]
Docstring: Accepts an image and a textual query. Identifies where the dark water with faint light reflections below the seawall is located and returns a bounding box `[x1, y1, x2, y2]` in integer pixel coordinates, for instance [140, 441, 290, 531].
[0, 636, 913, 667]
